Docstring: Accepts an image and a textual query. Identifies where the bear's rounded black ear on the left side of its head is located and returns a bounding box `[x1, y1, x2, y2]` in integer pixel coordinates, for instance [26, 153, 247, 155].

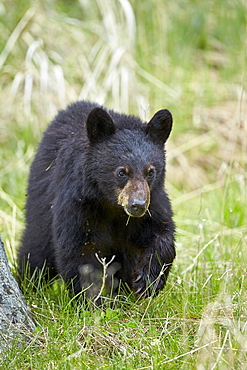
[86, 108, 115, 143]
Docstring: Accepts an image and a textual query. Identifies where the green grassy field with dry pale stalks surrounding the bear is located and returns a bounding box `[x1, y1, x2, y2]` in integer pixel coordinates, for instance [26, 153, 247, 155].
[0, 0, 247, 370]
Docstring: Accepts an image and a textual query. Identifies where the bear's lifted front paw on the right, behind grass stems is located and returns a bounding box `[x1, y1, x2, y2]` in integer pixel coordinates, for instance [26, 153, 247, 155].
[132, 235, 176, 298]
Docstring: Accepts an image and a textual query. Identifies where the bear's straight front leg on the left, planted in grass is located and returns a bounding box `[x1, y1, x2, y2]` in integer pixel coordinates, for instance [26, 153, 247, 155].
[52, 197, 97, 295]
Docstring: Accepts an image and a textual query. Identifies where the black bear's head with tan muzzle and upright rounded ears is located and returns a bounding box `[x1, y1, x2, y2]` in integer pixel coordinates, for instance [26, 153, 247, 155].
[86, 107, 172, 217]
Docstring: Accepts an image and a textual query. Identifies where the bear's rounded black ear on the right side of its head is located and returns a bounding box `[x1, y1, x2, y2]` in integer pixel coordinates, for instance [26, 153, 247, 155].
[146, 109, 172, 144]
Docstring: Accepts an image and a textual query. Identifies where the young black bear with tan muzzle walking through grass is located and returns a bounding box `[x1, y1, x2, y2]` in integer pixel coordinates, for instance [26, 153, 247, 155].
[19, 101, 175, 298]
